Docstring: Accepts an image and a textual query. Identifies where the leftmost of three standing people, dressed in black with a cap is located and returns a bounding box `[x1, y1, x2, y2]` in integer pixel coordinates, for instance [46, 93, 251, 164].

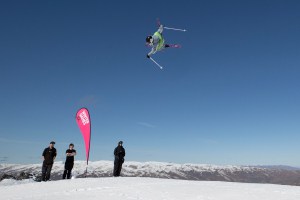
[42, 141, 57, 181]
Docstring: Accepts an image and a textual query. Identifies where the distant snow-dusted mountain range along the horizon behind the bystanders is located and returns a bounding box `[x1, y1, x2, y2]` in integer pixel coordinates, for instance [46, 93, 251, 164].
[0, 161, 300, 186]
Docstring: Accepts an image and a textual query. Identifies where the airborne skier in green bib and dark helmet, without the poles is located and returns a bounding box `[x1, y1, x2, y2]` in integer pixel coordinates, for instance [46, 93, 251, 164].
[146, 24, 170, 58]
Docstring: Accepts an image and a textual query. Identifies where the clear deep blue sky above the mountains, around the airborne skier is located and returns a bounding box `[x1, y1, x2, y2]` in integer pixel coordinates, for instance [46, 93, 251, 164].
[0, 0, 300, 166]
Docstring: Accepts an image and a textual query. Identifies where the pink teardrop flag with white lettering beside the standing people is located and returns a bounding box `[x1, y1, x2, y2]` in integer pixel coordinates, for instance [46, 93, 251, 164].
[76, 108, 91, 165]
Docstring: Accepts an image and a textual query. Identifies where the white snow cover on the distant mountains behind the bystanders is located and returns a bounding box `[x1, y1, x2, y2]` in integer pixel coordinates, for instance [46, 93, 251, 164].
[0, 160, 264, 176]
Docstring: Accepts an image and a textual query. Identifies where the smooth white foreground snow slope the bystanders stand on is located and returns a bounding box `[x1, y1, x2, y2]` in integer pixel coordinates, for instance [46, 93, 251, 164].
[0, 177, 300, 200]
